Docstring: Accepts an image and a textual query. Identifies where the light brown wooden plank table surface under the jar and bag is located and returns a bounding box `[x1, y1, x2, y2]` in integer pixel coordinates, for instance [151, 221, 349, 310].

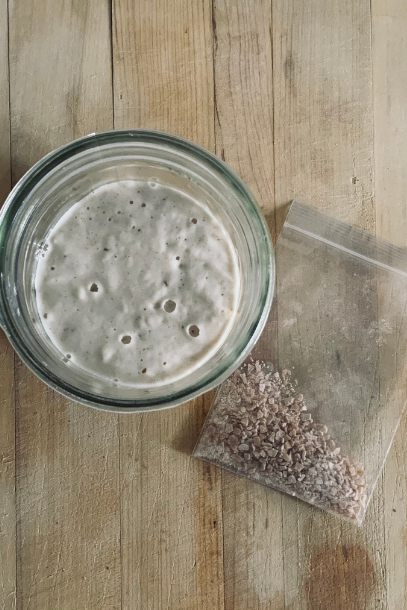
[0, 0, 407, 610]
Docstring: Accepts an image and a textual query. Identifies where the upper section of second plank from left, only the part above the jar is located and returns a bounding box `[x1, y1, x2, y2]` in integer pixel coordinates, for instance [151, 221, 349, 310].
[10, 0, 113, 182]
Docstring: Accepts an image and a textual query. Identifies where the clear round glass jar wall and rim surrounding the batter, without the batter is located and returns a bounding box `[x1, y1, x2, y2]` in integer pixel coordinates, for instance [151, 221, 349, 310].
[0, 130, 275, 412]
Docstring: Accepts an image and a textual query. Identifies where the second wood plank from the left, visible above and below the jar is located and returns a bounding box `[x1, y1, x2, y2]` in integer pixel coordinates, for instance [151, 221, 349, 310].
[10, 0, 121, 610]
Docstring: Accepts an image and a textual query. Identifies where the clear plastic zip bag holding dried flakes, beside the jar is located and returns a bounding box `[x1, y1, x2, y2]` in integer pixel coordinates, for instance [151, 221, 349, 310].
[194, 202, 407, 525]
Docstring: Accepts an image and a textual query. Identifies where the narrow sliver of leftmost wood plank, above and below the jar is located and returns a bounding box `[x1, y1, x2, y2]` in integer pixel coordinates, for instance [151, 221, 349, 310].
[0, 2, 16, 610]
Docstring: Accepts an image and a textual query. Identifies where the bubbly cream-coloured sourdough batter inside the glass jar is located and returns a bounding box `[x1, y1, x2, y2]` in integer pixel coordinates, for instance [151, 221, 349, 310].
[35, 180, 240, 386]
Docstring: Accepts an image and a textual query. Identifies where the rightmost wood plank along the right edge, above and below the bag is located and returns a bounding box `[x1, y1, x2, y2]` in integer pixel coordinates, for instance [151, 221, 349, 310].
[372, 0, 407, 610]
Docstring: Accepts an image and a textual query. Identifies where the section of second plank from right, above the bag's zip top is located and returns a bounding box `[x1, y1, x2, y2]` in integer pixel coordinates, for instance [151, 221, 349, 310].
[273, 0, 374, 229]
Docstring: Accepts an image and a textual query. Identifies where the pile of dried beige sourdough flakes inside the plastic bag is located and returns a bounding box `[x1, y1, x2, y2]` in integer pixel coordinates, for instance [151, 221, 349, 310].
[194, 361, 366, 522]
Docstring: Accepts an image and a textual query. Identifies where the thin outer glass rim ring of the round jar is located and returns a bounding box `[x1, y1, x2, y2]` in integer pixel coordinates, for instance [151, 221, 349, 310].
[0, 129, 275, 413]
